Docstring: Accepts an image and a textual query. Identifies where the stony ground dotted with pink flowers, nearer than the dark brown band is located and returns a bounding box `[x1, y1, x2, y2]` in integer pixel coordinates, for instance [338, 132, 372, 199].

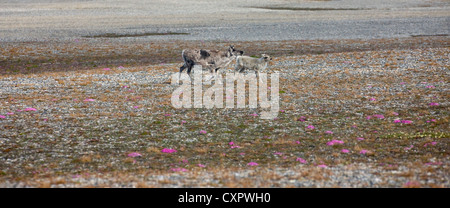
[0, 47, 450, 187]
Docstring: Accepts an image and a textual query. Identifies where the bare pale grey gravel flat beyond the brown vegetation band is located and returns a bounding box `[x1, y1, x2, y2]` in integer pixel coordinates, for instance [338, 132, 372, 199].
[0, 0, 450, 42]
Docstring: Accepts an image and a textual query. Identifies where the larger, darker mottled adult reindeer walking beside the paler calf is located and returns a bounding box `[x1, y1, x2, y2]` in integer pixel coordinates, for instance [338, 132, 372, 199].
[180, 45, 244, 80]
